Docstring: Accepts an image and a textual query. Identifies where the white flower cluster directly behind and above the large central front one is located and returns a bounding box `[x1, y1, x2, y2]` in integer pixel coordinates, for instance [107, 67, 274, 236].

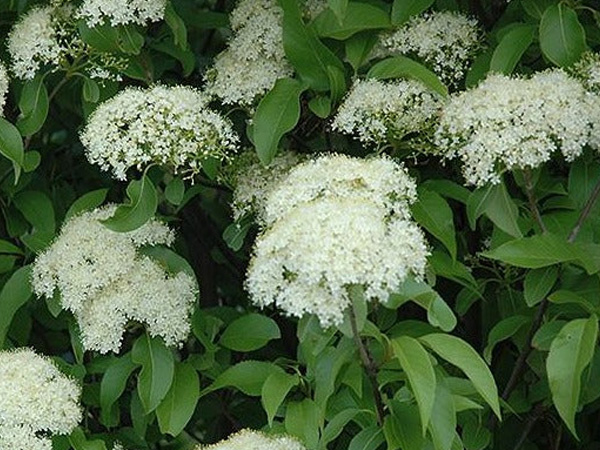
[264, 154, 417, 225]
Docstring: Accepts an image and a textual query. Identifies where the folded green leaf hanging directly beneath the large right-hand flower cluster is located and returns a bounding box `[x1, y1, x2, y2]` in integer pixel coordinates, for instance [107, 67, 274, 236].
[467, 183, 523, 237]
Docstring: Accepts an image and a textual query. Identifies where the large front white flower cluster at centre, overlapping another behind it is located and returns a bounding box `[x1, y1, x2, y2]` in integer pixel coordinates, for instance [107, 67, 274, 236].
[246, 197, 428, 327]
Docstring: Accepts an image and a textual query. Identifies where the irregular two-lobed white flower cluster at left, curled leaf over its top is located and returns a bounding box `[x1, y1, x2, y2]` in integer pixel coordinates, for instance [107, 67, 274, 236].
[32, 206, 197, 353]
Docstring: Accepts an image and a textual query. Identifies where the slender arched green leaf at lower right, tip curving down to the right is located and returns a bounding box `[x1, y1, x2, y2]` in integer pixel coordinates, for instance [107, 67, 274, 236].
[419, 333, 500, 418]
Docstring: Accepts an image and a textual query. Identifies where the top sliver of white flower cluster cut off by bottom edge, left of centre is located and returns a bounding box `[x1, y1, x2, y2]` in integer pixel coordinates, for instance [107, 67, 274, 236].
[196, 429, 306, 450]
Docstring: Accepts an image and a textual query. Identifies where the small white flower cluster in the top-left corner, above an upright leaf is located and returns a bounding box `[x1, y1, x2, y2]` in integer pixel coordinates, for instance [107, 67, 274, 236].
[8, 6, 65, 79]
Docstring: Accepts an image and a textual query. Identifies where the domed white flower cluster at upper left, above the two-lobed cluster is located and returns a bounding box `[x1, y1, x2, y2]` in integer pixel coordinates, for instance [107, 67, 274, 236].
[81, 85, 238, 180]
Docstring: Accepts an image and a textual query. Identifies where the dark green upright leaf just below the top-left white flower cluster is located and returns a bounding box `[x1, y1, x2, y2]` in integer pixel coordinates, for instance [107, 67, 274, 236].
[17, 75, 49, 136]
